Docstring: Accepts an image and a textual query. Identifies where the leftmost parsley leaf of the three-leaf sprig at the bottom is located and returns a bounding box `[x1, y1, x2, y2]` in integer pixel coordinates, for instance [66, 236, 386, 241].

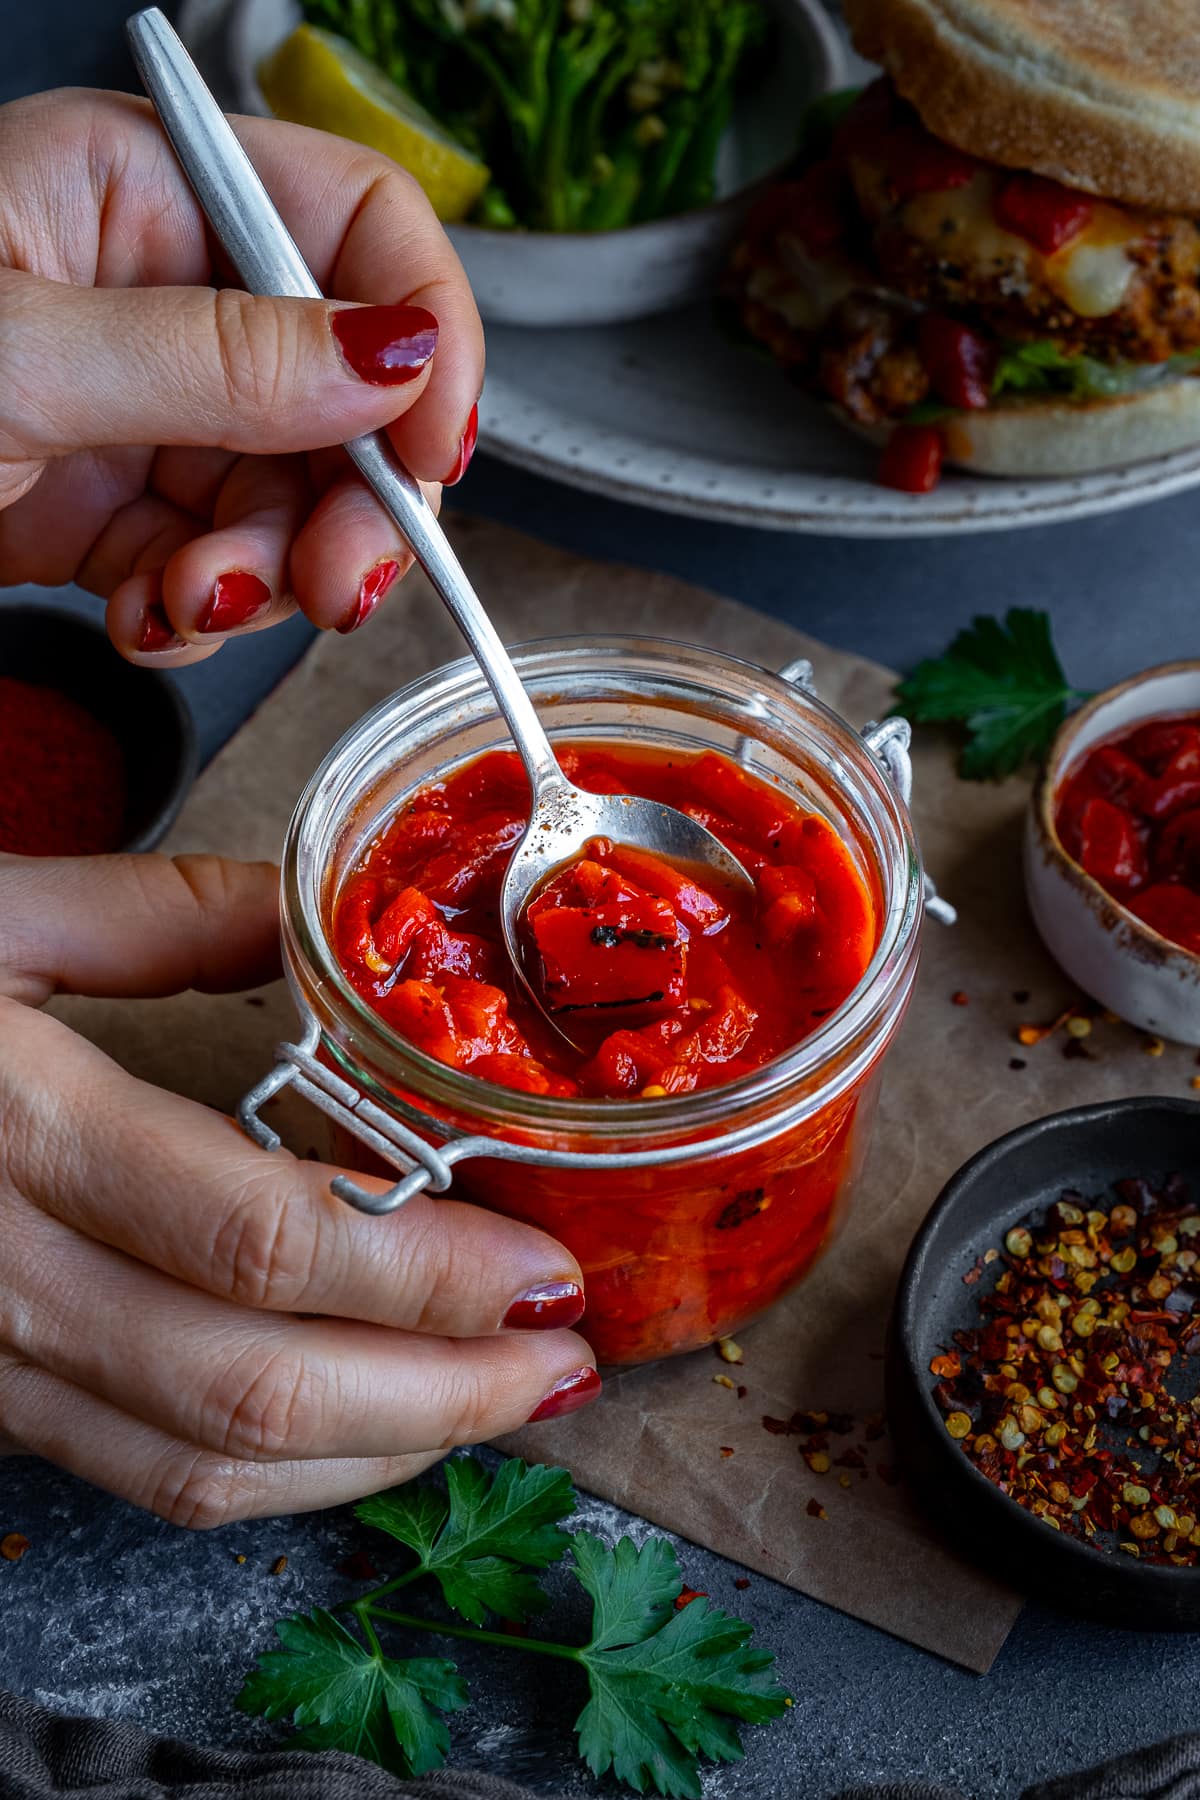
[237, 1607, 468, 1775]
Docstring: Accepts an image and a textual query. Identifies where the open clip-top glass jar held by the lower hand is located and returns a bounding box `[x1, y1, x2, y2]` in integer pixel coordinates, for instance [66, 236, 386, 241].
[255, 639, 923, 1364]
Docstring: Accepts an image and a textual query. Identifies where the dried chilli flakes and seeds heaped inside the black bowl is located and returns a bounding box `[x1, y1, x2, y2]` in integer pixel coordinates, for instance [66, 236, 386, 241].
[935, 1175, 1200, 1566]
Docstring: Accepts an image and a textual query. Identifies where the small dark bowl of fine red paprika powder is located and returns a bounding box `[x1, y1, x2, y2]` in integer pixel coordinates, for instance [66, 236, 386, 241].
[0, 601, 196, 855]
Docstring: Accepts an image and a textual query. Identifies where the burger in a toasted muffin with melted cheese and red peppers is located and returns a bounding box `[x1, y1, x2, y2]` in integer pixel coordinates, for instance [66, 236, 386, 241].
[727, 0, 1200, 493]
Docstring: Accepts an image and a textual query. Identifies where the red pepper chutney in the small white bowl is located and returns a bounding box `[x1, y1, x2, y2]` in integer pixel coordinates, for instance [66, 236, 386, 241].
[1054, 713, 1200, 954]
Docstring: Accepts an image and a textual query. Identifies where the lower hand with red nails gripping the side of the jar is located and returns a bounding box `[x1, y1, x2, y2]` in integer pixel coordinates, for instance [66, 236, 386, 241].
[0, 857, 599, 1526]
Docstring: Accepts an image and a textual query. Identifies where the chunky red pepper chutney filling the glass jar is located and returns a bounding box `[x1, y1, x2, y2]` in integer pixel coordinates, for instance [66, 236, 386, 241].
[333, 743, 880, 1363]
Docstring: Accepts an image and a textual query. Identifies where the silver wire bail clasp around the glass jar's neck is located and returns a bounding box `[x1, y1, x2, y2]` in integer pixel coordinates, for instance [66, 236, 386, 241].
[237, 657, 957, 1217]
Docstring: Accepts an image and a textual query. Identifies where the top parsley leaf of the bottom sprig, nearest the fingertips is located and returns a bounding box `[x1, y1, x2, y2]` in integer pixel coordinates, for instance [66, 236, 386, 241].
[356, 1456, 576, 1625]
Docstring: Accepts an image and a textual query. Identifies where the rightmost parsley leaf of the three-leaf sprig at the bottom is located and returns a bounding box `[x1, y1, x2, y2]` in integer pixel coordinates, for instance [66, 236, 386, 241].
[572, 1532, 788, 1800]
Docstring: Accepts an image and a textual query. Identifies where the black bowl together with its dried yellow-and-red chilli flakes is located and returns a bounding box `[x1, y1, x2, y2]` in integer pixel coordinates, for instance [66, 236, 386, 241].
[887, 1094, 1200, 1631]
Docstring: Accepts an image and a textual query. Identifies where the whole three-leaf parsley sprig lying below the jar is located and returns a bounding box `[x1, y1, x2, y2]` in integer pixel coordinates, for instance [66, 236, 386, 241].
[237, 1456, 788, 1800]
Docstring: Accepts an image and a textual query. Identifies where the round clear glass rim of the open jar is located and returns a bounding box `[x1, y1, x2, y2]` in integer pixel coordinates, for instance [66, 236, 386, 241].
[281, 634, 923, 1141]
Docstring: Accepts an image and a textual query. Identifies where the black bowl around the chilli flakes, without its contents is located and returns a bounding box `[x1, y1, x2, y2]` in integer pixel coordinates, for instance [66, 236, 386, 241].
[887, 1096, 1200, 1631]
